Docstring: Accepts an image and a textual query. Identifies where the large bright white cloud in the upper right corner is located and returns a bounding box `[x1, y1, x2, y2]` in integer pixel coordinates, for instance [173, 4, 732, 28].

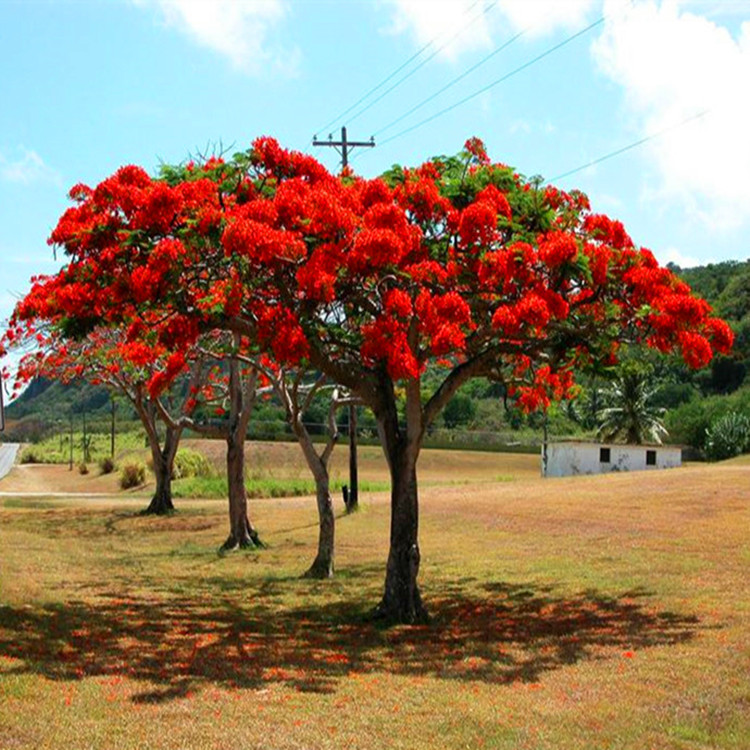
[592, 0, 750, 229]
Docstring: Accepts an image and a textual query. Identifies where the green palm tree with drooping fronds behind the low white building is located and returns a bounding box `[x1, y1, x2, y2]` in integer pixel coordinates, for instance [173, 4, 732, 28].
[597, 370, 668, 445]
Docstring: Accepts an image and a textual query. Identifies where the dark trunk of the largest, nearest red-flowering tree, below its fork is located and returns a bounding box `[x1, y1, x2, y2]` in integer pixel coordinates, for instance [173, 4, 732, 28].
[375, 438, 428, 624]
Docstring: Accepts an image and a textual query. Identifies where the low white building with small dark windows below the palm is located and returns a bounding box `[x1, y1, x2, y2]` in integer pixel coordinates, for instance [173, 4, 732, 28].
[542, 441, 682, 477]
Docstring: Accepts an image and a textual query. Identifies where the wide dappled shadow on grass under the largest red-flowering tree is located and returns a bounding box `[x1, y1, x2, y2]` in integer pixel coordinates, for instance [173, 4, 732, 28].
[0, 583, 701, 703]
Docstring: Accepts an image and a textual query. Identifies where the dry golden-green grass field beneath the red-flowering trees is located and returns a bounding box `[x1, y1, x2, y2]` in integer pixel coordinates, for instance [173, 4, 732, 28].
[0, 446, 750, 750]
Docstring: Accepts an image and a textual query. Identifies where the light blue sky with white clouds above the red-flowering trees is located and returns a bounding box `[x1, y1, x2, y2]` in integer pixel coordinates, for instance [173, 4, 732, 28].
[0, 0, 750, 334]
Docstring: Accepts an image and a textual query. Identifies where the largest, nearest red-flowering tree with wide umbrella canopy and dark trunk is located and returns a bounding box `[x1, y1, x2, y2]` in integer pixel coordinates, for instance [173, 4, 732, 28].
[10, 138, 732, 622]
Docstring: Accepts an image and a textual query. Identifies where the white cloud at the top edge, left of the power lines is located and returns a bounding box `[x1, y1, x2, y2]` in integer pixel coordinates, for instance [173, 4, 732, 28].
[132, 0, 299, 75]
